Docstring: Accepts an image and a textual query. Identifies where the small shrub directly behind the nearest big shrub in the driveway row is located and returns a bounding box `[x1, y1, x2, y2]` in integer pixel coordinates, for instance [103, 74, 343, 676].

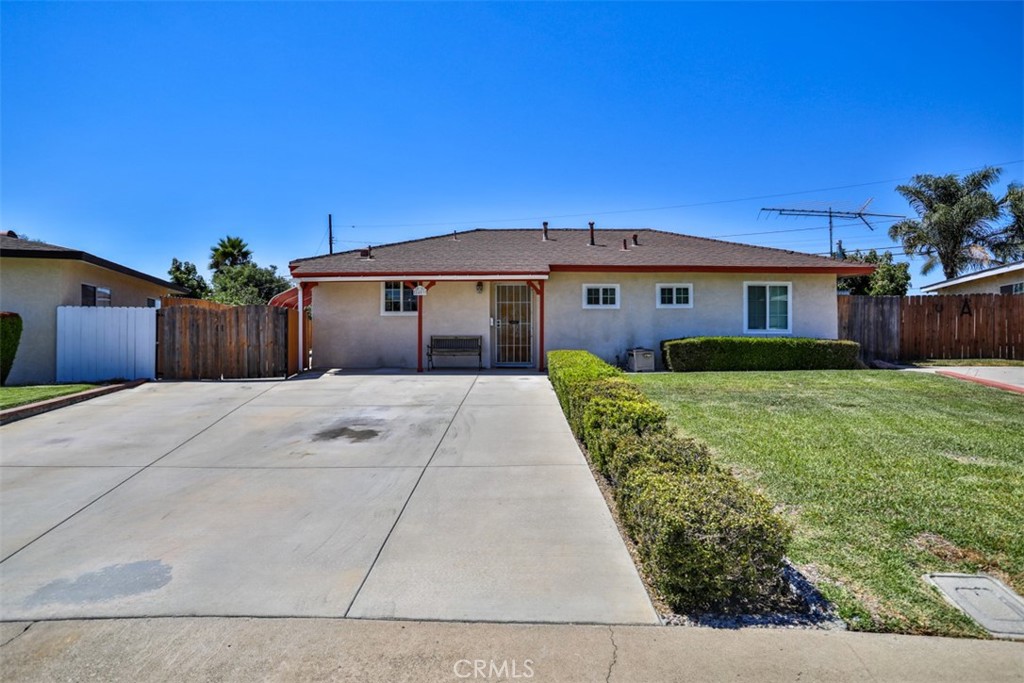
[602, 432, 718, 485]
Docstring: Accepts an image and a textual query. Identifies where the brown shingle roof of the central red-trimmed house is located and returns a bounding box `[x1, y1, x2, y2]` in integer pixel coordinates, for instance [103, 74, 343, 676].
[290, 228, 871, 278]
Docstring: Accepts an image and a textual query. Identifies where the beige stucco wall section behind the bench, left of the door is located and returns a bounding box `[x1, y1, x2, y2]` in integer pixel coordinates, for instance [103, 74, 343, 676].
[312, 282, 490, 368]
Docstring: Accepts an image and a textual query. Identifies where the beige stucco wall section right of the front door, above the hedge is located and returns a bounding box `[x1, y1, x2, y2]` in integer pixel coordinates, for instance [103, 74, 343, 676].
[546, 272, 839, 362]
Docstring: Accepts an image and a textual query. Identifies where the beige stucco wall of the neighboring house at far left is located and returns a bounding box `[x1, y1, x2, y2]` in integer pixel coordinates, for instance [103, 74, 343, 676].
[0, 258, 176, 385]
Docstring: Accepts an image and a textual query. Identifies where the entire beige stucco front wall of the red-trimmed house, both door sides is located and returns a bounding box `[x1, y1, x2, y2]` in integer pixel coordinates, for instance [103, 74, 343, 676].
[312, 272, 838, 368]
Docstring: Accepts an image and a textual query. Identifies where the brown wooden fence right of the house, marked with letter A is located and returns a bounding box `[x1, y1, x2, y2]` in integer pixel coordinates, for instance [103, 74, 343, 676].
[839, 294, 1024, 360]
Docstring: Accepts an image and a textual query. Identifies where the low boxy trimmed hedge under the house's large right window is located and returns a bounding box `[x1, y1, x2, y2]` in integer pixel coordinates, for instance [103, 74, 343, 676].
[662, 337, 861, 373]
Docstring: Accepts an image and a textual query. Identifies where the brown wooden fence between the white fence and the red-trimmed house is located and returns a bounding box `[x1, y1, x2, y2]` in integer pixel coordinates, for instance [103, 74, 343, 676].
[157, 305, 295, 380]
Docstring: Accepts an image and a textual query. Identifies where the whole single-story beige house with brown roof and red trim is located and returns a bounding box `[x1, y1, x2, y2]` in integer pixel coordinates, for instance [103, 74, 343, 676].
[290, 226, 873, 369]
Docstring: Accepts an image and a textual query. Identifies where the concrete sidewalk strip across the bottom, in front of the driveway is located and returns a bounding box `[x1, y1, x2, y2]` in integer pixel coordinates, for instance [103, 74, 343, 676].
[0, 617, 1024, 683]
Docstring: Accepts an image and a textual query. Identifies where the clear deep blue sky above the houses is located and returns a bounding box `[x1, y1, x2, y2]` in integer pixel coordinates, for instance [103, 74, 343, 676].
[0, 2, 1024, 288]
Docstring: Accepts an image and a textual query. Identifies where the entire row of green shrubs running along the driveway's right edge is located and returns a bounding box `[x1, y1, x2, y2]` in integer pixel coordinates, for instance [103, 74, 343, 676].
[548, 350, 791, 612]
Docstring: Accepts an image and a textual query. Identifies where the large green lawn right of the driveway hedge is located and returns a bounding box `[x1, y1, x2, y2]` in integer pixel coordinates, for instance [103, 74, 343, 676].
[630, 371, 1024, 636]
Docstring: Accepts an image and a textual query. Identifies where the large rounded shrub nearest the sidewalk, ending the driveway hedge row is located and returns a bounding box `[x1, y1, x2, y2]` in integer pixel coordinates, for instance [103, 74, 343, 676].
[615, 467, 791, 611]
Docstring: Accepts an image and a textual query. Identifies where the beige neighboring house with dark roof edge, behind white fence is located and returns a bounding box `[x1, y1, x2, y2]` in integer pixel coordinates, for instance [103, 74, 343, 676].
[0, 232, 185, 384]
